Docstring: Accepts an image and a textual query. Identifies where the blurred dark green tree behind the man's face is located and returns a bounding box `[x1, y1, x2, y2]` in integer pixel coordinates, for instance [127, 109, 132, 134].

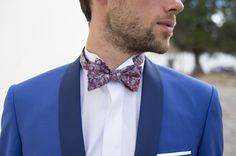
[173, 0, 236, 73]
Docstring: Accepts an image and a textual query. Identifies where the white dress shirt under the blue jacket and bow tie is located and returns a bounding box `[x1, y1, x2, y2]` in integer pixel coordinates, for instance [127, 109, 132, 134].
[80, 50, 144, 156]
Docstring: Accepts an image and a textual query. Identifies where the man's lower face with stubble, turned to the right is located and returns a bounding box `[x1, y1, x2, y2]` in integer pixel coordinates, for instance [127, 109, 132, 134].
[105, 0, 183, 54]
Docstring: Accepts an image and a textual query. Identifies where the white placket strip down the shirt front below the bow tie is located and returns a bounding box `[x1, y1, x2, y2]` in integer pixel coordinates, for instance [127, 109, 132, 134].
[102, 83, 123, 156]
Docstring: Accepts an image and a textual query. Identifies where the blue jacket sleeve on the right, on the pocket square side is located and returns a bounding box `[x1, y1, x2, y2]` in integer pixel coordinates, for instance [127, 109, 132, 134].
[199, 88, 224, 156]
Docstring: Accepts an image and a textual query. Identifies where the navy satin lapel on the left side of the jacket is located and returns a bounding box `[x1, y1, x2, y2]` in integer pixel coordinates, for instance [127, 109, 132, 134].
[59, 59, 85, 156]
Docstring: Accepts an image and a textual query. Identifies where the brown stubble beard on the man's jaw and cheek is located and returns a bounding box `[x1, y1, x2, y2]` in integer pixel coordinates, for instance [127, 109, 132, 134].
[105, 3, 170, 55]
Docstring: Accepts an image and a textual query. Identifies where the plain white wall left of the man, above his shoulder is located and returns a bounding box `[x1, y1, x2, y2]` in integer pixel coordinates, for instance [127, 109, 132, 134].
[0, 0, 88, 122]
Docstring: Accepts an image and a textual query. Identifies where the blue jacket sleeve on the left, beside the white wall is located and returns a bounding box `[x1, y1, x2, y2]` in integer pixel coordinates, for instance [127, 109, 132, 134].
[0, 86, 22, 156]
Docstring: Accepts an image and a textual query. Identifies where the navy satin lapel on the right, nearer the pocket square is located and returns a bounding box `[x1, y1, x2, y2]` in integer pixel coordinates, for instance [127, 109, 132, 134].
[135, 58, 163, 156]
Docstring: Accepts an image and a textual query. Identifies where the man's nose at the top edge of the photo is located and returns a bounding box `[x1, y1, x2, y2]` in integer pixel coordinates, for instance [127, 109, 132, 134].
[166, 0, 184, 15]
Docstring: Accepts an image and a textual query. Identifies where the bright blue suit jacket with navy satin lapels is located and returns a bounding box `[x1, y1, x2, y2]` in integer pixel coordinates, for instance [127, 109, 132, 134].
[0, 59, 223, 156]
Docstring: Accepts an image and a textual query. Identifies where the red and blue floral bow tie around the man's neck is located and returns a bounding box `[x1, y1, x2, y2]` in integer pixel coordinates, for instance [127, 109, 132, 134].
[80, 51, 144, 91]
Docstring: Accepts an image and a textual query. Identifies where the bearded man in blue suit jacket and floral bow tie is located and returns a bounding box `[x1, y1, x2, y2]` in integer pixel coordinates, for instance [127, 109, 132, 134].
[0, 0, 223, 156]
